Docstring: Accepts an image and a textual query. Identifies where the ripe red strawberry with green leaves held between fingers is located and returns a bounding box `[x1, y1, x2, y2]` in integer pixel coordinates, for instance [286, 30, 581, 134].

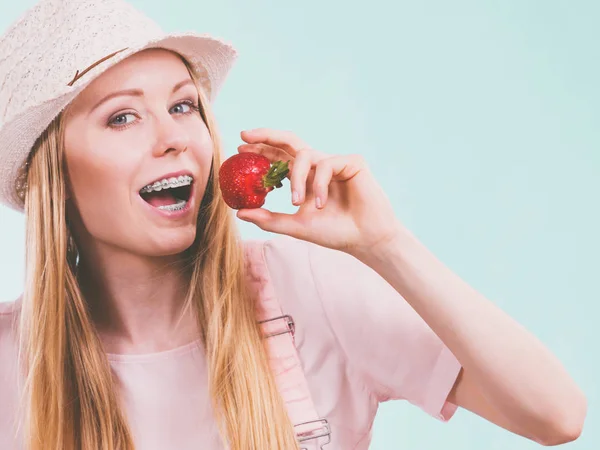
[219, 153, 289, 209]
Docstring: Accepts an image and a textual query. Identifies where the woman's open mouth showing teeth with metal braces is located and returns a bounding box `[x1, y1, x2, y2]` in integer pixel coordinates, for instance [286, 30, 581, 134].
[140, 175, 194, 211]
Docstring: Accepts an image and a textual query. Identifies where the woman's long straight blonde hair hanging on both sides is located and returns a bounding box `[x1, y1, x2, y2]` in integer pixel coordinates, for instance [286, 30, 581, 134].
[19, 55, 298, 450]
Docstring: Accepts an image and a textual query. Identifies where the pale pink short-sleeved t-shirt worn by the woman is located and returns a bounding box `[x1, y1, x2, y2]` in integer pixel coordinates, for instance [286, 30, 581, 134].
[0, 236, 460, 450]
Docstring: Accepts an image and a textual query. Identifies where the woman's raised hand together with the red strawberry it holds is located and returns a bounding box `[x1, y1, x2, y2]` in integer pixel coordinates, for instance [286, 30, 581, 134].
[220, 128, 400, 256]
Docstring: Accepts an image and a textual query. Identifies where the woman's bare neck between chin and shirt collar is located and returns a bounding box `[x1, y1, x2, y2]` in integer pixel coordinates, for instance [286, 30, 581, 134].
[78, 249, 199, 354]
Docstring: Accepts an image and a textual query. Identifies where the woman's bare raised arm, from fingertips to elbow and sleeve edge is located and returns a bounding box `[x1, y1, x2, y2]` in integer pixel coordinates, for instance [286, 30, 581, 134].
[233, 128, 587, 445]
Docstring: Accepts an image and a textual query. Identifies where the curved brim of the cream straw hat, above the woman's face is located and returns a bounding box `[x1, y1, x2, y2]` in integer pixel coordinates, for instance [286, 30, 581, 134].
[0, 33, 237, 212]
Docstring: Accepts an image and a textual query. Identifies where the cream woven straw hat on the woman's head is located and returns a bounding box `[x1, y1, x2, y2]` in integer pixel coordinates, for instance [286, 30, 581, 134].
[0, 0, 236, 211]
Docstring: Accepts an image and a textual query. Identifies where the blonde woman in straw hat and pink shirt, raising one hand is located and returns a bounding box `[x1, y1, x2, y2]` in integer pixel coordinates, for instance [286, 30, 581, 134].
[0, 0, 586, 450]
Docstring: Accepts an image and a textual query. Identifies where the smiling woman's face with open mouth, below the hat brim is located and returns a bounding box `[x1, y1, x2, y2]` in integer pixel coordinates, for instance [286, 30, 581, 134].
[65, 49, 213, 256]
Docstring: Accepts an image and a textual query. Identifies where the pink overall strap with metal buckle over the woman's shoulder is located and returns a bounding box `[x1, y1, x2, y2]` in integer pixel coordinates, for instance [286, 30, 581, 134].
[244, 241, 331, 448]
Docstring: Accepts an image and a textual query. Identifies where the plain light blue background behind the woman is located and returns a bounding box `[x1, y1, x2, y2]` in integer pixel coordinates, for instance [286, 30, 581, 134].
[0, 0, 600, 450]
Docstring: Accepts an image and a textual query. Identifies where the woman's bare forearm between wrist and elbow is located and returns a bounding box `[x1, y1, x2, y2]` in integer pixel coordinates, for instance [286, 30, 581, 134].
[355, 228, 586, 436]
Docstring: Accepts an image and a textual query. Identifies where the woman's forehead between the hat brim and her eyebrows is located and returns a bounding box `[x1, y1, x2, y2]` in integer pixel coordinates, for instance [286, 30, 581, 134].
[69, 49, 190, 110]
